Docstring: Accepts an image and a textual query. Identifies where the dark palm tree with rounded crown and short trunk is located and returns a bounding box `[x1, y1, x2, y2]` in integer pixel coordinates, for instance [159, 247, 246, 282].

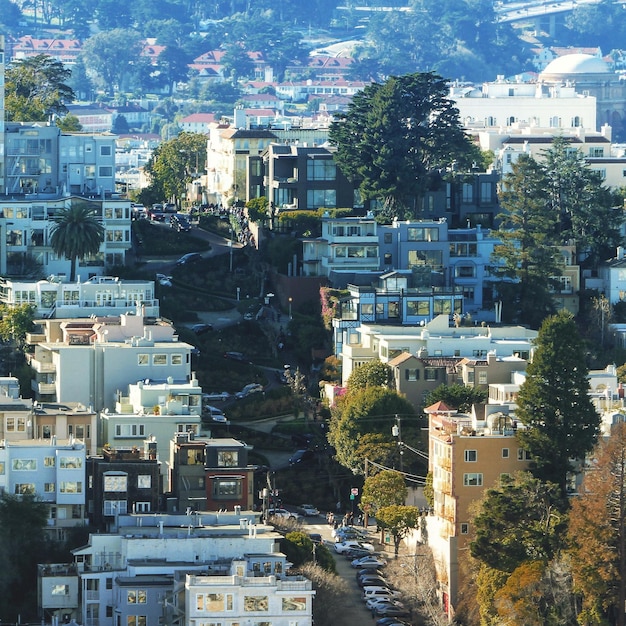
[50, 202, 104, 281]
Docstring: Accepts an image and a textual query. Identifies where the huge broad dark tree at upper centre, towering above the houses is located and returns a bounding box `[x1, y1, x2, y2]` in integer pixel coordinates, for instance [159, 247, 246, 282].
[329, 73, 478, 218]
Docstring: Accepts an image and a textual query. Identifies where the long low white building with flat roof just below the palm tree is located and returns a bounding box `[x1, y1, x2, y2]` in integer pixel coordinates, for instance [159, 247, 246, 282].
[0, 275, 159, 319]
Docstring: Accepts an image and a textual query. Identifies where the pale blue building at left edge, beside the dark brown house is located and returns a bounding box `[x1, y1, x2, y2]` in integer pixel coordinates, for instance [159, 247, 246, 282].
[0, 437, 86, 539]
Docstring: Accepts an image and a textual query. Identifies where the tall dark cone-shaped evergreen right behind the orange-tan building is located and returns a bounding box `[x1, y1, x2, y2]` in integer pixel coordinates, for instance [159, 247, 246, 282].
[516, 311, 600, 496]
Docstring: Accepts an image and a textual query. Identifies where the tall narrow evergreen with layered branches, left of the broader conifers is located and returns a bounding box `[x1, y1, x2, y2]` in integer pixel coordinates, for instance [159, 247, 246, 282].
[491, 155, 559, 328]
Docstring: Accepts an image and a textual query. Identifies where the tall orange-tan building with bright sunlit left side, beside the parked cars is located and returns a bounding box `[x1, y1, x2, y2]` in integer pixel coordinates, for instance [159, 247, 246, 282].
[425, 402, 528, 616]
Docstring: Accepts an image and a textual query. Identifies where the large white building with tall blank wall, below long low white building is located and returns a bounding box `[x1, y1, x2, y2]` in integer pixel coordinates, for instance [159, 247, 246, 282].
[26, 307, 193, 411]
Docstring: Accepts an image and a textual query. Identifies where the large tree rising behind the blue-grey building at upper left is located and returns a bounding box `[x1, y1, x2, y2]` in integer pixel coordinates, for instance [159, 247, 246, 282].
[4, 54, 75, 122]
